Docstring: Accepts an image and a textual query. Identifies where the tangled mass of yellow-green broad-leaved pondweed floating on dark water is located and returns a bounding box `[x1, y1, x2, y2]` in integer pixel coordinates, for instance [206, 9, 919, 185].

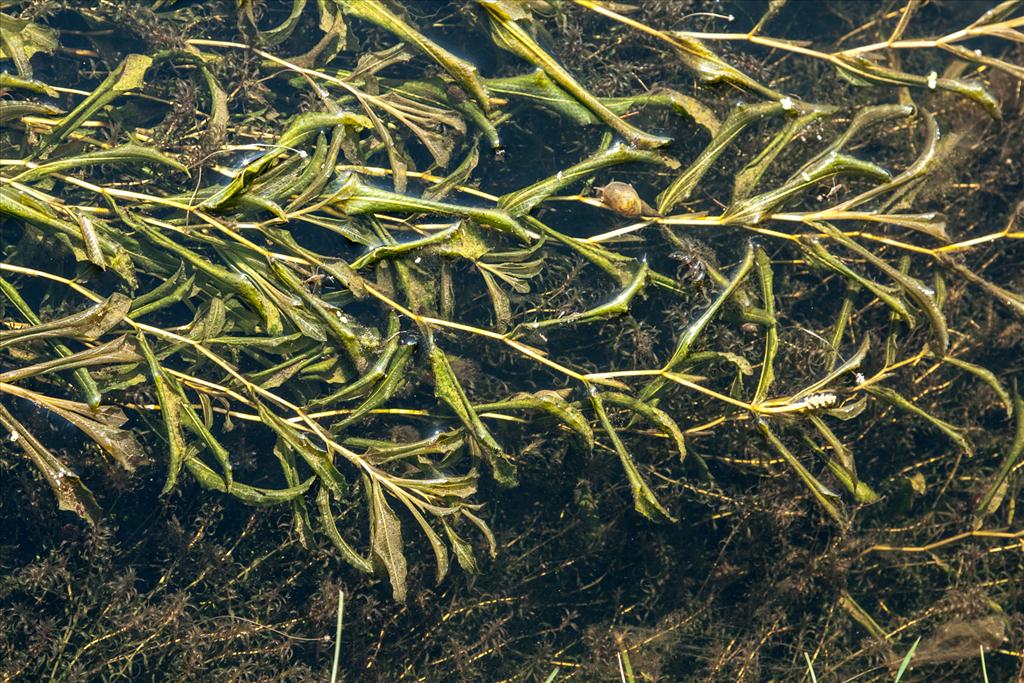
[0, 0, 1024, 675]
